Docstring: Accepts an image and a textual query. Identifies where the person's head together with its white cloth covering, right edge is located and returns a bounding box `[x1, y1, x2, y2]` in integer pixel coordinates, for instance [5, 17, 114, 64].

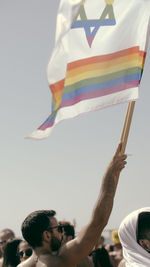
[119, 207, 150, 266]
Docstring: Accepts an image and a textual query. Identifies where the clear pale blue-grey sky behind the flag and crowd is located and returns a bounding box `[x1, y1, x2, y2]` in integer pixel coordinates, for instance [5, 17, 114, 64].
[0, 0, 150, 239]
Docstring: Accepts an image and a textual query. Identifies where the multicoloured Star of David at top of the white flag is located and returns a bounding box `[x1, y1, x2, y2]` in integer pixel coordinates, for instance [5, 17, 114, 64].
[71, 4, 116, 47]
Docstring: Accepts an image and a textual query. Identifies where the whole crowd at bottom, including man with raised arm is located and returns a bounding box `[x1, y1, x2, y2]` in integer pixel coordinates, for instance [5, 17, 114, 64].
[0, 143, 150, 267]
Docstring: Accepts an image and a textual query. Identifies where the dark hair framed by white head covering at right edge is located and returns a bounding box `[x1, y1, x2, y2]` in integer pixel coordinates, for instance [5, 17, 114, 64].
[136, 212, 150, 243]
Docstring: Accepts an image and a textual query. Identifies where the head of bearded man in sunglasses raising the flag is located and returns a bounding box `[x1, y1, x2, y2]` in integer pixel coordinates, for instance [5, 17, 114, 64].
[21, 210, 62, 251]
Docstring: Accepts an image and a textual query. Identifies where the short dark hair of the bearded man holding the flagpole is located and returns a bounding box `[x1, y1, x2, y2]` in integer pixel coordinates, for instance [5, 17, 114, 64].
[21, 210, 56, 248]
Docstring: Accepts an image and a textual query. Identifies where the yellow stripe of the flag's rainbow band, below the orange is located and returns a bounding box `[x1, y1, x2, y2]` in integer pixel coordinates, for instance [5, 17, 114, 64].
[65, 60, 143, 86]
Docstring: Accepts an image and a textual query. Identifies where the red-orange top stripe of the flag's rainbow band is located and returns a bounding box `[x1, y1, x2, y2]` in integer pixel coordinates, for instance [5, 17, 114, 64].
[68, 46, 139, 70]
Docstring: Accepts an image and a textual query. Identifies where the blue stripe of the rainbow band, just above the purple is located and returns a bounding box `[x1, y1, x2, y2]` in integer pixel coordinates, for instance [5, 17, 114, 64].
[62, 73, 141, 101]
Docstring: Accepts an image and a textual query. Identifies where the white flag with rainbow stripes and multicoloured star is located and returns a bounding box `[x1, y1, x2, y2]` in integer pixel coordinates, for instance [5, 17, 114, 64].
[30, 0, 150, 139]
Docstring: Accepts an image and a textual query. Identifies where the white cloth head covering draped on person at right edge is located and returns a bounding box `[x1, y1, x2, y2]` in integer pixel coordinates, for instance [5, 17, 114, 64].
[119, 207, 150, 267]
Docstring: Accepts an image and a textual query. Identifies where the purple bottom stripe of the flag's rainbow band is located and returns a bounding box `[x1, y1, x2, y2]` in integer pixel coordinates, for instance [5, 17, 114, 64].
[61, 80, 139, 108]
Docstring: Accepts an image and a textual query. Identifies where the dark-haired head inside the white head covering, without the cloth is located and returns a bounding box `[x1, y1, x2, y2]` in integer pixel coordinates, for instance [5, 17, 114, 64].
[136, 212, 150, 253]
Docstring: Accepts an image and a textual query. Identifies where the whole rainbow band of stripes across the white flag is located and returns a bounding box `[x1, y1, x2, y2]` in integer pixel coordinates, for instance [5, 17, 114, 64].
[39, 46, 146, 130]
